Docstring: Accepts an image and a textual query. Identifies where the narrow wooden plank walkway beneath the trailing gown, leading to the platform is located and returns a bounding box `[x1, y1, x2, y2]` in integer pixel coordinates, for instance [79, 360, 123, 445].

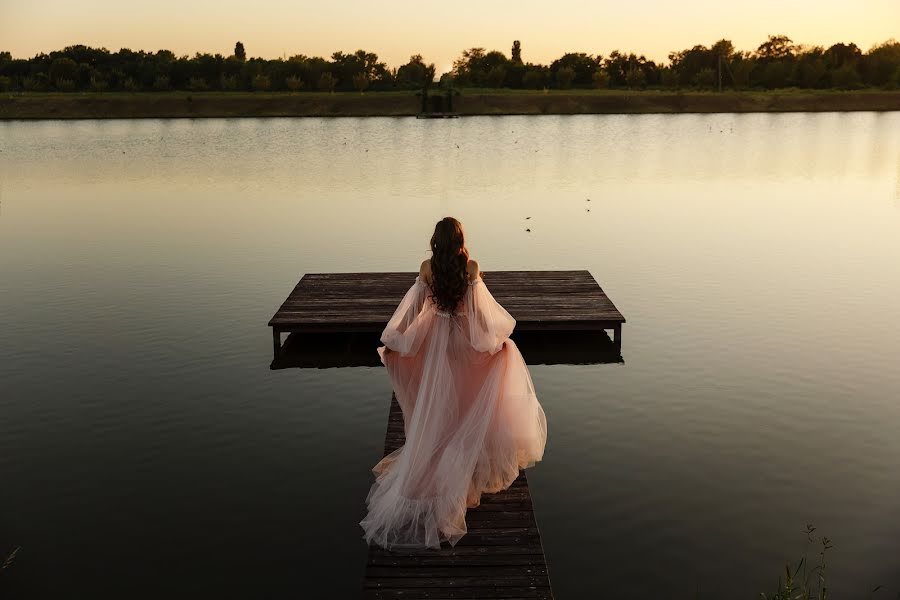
[363, 398, 553, 600]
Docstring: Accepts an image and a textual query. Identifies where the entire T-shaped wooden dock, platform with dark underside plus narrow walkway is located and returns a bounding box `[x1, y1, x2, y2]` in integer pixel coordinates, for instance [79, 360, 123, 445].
[269, 271, 625, 599]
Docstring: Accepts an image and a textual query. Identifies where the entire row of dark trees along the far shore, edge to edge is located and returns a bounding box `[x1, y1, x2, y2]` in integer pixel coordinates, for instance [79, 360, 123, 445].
[0, 35, 900, 92]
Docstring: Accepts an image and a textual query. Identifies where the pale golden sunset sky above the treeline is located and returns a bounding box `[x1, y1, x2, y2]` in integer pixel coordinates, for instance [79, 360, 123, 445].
[0, 0, 900, 72]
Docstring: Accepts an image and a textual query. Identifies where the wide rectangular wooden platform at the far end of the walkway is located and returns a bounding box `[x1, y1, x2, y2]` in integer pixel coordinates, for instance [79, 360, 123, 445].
[269, 271, 625, 359]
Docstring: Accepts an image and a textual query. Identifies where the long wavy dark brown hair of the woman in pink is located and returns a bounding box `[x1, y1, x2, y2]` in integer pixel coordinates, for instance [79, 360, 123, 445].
[431, 217, 469, 311]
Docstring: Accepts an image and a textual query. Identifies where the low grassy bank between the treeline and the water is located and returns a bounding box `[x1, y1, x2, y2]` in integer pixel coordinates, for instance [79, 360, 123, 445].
[0, 89, 900, 119]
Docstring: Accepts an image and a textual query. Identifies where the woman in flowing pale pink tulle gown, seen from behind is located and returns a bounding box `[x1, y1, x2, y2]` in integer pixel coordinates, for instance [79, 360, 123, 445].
[360, 217, 547, 549]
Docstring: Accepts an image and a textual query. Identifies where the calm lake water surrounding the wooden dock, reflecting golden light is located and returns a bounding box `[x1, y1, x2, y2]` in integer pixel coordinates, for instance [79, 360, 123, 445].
[0, 113, 900, 599]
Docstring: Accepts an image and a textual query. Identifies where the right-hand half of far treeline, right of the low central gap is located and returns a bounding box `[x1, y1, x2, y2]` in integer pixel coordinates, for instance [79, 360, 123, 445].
[452, 35, 900, 89]
